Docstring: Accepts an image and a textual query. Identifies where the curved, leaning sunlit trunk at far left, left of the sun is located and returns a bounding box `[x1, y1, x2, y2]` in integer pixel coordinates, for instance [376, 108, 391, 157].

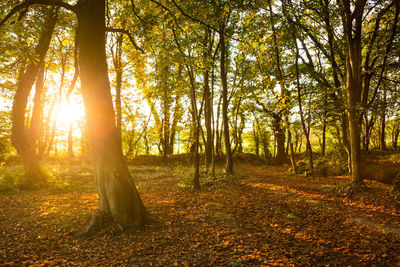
[11, 6, 57, 187]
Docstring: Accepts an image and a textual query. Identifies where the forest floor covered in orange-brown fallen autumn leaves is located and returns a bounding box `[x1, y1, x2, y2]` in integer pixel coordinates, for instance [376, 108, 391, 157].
[0, 159, 400, 266]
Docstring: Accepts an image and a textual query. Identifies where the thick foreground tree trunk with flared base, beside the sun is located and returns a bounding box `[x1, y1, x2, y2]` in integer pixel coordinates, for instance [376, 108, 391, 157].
[76, 0, 148, 233]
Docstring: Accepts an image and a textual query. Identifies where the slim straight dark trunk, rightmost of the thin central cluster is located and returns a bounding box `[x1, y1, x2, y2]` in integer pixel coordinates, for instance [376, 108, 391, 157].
[219, 22, 233, 174]
